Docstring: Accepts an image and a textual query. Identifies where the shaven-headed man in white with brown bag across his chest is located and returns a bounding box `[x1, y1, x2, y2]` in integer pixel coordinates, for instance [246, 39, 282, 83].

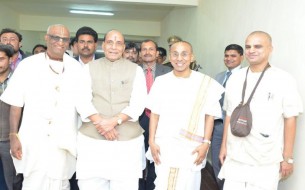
[219, 31, 303, 190]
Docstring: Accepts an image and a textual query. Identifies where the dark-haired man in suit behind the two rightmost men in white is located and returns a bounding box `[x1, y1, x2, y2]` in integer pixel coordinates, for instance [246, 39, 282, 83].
[211, 44, 244, 190]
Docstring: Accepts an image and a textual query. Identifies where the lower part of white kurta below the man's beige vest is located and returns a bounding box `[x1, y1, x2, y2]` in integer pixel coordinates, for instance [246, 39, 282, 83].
[76, 133, 144, 189]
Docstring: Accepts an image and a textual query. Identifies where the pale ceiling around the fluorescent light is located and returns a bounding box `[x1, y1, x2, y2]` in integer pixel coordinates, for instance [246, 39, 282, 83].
[1, 0, 198, 21]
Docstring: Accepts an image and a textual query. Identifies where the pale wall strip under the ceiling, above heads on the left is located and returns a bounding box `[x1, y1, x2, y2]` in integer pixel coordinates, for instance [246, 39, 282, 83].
[19, 15, 161, 51]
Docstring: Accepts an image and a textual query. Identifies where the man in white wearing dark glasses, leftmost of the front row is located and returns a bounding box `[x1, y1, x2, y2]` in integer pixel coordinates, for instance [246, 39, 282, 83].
[1, 24, 101, 190]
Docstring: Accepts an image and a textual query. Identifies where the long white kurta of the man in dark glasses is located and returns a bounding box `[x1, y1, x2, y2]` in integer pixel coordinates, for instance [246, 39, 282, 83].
[1, 53, 96, 179]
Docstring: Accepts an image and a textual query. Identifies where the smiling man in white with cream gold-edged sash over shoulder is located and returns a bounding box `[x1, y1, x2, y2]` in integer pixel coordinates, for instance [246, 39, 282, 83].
[146, 41, 224, 190]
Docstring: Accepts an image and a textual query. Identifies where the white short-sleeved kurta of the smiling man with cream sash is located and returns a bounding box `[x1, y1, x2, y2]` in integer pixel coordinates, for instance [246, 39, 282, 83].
[147, 71, 223, 171]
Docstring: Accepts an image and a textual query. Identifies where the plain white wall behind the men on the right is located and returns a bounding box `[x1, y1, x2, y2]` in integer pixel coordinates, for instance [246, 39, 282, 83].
[159, 0, 305, 190]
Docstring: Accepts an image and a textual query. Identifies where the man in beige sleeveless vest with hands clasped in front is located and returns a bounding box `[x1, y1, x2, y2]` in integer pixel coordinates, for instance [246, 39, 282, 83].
[76, 30, 147, 190]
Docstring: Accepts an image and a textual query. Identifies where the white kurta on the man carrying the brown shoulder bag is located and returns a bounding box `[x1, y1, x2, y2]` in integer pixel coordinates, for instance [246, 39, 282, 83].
[219, 66, 303, 189]
